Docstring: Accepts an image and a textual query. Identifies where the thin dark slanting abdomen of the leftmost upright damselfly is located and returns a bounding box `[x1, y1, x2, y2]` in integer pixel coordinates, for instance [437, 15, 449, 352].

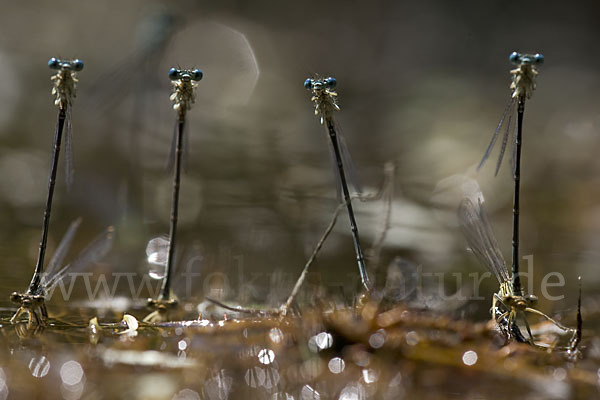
[27, 107, 67, 294]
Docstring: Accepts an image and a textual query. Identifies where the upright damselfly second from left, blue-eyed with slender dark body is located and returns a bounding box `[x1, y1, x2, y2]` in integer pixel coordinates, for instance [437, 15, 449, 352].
[144, 68, 203, 322]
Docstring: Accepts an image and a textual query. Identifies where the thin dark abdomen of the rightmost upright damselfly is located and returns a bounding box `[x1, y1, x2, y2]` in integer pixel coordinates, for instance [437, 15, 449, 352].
[512, 97, 525, 296]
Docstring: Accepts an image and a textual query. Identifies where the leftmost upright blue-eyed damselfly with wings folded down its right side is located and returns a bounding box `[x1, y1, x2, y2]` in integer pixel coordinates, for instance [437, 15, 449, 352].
[17, 58, 83, 324]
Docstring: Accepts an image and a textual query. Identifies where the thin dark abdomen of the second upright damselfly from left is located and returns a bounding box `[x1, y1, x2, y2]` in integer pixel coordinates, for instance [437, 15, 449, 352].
[161, 117, 185, 300]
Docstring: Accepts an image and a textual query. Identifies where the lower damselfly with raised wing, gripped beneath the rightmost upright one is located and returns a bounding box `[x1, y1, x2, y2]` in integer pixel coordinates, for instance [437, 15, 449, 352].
[458, 192, 577, 347]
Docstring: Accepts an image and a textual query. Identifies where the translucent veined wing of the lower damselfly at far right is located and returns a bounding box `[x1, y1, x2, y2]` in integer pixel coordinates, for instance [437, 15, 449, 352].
[458, 198, 510, 283]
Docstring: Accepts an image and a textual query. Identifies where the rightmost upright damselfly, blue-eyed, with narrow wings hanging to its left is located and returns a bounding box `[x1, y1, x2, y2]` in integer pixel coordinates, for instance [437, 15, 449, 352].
[477, 52, 544, 295]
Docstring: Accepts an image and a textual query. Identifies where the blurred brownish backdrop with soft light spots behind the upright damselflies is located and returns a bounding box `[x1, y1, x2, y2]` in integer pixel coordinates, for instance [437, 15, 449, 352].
[0, 0, 600, 319]
